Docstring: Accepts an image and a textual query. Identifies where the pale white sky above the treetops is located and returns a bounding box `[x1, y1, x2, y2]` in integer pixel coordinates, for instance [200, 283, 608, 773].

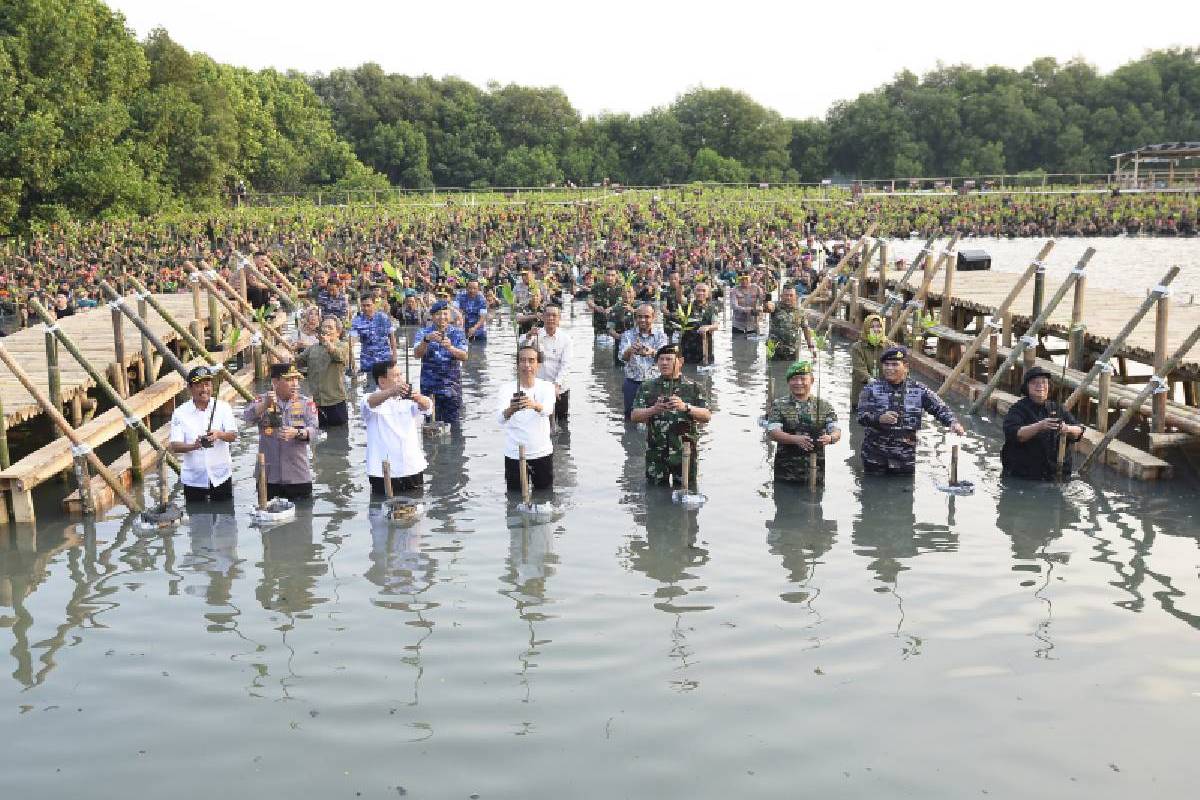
[108, 0, 1200, 118]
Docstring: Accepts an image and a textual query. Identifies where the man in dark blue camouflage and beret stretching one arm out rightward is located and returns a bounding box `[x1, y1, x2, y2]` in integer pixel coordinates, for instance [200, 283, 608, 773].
[858, 345, 962, 475]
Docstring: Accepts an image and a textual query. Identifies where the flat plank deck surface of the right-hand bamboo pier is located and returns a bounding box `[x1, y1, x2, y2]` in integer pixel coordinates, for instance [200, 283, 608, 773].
[869, 267, 1200, 379]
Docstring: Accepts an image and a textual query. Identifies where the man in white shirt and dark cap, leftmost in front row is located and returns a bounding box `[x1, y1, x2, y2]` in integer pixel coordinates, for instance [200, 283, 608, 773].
[167, 367, 238, 503]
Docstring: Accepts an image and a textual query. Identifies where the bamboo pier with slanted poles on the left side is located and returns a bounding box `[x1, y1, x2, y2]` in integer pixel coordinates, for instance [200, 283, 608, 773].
[0, 285, 286, 524]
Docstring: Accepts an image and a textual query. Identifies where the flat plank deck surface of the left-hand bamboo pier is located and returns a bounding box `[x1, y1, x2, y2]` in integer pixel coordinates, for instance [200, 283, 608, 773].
[0, 294, 208, 427]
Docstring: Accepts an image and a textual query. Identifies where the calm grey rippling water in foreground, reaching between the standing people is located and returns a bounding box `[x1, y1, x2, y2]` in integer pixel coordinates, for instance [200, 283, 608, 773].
[0, 287, 1200, 799]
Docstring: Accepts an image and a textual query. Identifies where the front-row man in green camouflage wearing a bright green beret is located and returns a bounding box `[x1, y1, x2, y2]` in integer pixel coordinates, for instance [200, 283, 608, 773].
[767, 361, 841, 485]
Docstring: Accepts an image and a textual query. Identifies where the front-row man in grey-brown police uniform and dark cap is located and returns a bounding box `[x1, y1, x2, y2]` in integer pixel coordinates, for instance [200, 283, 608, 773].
[241, 363, 317, 500]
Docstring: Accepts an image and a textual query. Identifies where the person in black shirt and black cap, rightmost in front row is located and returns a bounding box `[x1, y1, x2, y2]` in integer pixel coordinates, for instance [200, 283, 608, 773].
[1000, 367, 1085, 481]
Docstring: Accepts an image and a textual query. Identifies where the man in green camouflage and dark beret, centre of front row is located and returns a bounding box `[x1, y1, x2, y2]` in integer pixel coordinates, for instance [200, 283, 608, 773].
[630, 344, 713, 487]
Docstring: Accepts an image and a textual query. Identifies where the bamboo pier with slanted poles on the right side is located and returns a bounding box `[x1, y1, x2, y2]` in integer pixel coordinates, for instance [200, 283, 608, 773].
[808, 240, 1200, 480]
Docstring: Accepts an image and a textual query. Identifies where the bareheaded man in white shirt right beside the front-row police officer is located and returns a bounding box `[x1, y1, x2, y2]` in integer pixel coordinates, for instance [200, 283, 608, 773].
[359, 361, 433, 497]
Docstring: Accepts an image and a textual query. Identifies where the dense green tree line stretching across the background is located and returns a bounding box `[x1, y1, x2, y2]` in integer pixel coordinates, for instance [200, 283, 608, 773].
[0, 0, 1200, 233]
